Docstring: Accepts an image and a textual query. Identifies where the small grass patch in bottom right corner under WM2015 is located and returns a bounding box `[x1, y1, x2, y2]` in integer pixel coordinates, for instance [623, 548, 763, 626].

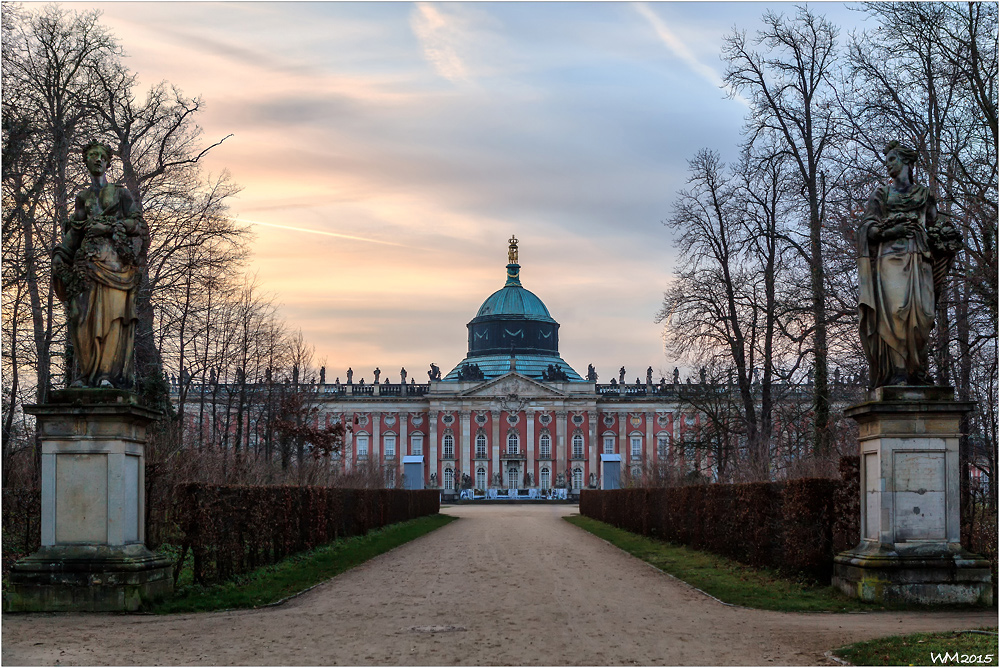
[833, 629, 1000, 666]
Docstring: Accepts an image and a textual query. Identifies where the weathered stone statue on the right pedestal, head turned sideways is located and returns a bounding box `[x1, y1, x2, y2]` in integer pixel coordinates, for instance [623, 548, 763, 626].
[858, 141, 962, 389]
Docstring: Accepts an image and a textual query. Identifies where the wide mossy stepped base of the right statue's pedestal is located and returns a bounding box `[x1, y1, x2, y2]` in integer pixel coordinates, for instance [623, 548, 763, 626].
[832, 541, 993, 605]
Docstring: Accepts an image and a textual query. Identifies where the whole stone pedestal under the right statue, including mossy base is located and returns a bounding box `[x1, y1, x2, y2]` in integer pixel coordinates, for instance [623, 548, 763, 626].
[833, 386, 993, 604]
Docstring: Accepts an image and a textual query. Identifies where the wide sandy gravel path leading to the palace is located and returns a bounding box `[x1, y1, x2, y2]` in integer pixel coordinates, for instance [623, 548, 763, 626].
[0, 505, 996, 666]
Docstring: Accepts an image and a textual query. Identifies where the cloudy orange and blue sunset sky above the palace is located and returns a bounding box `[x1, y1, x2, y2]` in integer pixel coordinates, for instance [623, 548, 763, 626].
[82, 2, 861, 381]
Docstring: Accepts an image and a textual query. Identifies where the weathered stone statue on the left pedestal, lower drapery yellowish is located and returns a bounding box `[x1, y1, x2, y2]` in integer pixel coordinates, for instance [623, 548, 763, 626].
[52, 142, 144, 389]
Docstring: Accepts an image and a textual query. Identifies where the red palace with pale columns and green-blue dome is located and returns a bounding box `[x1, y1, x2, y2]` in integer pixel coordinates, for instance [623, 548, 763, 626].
[174, 237, 700, 497]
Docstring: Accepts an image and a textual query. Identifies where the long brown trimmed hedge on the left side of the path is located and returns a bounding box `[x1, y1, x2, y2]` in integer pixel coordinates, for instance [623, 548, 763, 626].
[174, 483, 440, 584]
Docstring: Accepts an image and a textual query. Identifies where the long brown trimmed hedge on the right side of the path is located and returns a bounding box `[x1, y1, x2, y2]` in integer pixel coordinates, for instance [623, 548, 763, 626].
[580, 470, 860, 582]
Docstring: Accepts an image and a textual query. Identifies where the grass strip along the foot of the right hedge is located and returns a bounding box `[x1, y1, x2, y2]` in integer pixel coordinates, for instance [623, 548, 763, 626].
[565, 515, 968, 612]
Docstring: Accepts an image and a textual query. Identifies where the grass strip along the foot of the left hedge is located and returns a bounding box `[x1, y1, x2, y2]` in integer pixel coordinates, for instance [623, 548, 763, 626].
[150, 515, 457, 613]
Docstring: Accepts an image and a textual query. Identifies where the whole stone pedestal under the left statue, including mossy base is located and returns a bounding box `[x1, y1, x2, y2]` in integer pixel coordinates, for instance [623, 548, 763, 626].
[4, 389, 173, 611]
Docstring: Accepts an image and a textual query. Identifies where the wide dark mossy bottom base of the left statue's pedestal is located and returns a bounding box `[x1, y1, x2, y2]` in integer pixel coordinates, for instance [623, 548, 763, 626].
[4, 545, 173, 612]
